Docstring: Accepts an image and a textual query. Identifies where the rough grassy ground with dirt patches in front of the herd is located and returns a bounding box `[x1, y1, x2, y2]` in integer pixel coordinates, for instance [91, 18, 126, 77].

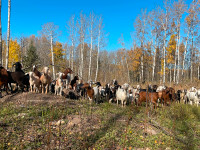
[0, 93, 200, 150]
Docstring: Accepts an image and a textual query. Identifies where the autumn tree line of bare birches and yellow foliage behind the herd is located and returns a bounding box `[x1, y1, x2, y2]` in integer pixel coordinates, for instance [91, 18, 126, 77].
[0, 0, 200, 84]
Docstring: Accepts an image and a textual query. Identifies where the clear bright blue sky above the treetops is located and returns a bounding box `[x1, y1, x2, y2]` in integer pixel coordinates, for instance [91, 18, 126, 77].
[2, 0, 192, 51]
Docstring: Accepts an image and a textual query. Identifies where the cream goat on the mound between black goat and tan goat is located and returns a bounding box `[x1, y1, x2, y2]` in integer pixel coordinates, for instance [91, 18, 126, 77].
[28, 72, 41, 92]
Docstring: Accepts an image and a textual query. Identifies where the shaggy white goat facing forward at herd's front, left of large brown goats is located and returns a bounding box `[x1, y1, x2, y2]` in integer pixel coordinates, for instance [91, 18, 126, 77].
[116, 88, 127, 107]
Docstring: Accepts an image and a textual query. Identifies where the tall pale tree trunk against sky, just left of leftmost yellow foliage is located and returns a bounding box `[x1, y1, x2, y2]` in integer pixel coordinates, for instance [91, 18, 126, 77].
[5, 0, 11, 69]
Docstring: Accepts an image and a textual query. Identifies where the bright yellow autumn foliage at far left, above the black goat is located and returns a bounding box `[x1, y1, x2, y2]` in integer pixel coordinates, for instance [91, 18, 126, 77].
[8, 39, 21, 68]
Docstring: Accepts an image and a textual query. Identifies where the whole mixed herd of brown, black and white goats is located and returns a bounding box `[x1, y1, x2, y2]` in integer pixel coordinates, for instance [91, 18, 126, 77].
[0, 62, 200, 108]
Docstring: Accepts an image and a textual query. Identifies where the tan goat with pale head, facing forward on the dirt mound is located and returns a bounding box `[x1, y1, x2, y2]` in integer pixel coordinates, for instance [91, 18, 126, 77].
[40, 67, 51, 94]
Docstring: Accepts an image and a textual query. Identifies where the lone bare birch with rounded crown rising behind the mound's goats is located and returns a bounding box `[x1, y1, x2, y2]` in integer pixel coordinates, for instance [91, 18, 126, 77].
[41, 22, 58, 79]
